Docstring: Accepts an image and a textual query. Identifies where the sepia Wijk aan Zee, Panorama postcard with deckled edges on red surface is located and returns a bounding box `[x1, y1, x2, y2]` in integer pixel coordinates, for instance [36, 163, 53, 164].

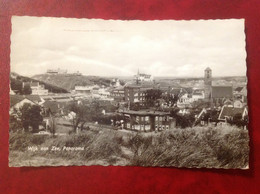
[9, 16, 250, 169]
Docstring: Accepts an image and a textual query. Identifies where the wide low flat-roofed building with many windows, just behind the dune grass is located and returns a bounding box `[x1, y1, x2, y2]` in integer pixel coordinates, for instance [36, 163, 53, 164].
[121, 110, 176, 131]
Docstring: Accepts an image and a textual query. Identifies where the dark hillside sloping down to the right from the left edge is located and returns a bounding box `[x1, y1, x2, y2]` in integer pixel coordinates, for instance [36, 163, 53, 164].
[10, 72, 68, 93]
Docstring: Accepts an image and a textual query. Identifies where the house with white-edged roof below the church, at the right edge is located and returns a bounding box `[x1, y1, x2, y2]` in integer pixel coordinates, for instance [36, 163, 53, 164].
[218, 106, 248, 122]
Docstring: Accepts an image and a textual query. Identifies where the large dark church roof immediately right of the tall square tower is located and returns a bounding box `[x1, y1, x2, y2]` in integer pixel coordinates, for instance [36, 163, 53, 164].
[211, 86, 233, 98]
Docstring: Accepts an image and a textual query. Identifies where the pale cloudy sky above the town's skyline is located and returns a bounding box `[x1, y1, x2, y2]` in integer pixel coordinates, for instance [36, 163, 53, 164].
[11, 16, 246, 77]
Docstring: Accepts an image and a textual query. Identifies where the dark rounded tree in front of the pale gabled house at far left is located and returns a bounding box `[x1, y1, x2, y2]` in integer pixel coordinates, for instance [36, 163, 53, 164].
[20, 103, 43, 132]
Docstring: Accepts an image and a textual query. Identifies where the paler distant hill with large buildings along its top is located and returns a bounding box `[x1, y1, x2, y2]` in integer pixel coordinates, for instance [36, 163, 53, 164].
[33, 74, 112, 91]
